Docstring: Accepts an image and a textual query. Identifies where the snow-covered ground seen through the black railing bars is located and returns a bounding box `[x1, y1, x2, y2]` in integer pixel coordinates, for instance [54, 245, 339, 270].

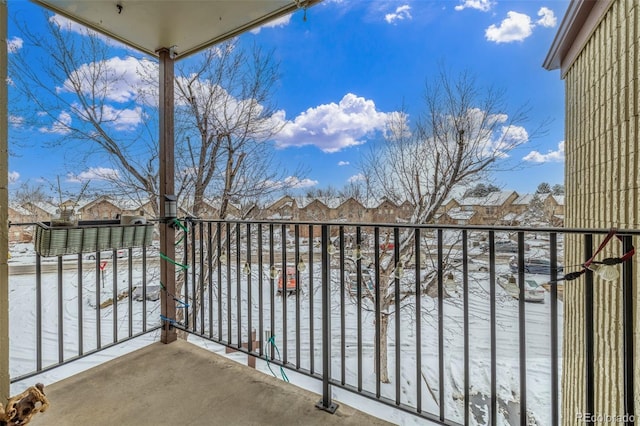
[9, 246, 562, 425]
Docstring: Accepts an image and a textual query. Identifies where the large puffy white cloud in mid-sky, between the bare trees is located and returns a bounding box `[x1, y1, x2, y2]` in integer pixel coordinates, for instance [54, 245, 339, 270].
[275, 93, 390, 152]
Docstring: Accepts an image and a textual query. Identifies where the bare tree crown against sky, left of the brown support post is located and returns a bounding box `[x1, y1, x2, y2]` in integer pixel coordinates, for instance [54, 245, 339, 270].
[9, 14, 158, 213]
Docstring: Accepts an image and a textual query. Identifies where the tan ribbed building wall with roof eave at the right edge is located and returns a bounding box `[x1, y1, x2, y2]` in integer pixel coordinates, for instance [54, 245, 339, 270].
[544, 0, 640, 424]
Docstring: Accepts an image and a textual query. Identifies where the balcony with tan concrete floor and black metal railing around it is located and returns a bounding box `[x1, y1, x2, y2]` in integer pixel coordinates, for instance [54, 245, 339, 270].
[9, 220, 638, 425]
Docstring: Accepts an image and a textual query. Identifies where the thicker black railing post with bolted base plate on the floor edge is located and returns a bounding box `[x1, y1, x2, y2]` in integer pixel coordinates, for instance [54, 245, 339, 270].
[316, 224, 338, 414]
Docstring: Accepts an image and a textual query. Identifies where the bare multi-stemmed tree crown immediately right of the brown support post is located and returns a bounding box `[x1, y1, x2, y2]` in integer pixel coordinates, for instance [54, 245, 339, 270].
[176, 41, 302, 218]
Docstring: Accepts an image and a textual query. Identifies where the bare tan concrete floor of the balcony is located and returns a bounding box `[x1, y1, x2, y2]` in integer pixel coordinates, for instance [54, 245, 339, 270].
[30, 340, 388, 426]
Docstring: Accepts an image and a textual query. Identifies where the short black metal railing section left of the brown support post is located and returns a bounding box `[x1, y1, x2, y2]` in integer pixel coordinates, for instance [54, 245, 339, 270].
[9, 223, 161, 383]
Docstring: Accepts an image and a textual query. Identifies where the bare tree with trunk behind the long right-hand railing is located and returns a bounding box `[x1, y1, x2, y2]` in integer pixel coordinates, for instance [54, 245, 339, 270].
[361, 69, 544, 382]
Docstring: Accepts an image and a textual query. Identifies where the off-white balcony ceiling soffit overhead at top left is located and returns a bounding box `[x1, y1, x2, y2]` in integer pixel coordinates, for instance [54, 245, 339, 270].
[32, 0, 321, 57]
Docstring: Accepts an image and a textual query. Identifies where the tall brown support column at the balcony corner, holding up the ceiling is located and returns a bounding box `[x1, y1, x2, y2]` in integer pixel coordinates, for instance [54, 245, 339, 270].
[158, 48, 178, 343]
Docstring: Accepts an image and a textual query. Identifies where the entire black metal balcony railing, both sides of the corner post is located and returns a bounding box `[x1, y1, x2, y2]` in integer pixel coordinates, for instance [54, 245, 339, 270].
[10, 219, 640, 425]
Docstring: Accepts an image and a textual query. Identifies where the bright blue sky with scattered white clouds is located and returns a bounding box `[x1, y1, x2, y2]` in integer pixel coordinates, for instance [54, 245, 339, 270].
[8, 0, 569, 196]
